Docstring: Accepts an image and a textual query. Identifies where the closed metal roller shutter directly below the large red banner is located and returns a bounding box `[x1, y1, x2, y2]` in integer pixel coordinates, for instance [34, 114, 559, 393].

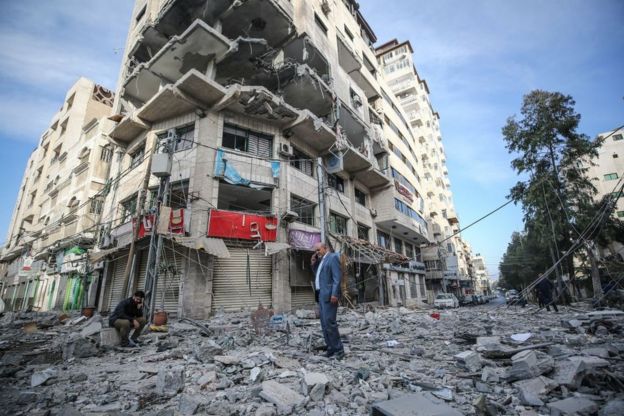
[212, 247, 272, 311]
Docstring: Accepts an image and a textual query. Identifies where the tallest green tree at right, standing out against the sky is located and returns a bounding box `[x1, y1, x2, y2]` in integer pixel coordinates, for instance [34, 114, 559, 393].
[502, 90, 600, 296]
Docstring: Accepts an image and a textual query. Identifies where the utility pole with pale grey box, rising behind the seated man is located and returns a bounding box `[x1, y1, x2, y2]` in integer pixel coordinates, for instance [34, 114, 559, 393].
[145, 129, 176, 322]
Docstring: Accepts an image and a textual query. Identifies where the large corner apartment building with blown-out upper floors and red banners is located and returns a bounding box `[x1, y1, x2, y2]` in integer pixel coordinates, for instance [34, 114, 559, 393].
[1, 0, 482, 318]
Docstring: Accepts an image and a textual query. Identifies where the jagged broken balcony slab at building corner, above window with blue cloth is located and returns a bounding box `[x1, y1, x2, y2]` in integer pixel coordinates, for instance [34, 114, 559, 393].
[215, 84, 299, 125]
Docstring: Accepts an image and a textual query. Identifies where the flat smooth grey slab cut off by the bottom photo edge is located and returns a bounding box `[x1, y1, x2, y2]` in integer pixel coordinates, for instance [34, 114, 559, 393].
[371, 393, 462, 416]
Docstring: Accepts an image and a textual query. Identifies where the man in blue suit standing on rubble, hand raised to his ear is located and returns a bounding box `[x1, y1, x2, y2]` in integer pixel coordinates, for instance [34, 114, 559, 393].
[311, 243, 344, 360]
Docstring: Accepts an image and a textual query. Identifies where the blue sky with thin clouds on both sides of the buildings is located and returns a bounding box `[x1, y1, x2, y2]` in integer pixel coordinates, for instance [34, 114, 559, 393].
[0, 0, 624, 274]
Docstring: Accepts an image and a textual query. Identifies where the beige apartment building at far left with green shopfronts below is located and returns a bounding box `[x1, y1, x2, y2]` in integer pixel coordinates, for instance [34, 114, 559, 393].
[0, 78, 113, 310]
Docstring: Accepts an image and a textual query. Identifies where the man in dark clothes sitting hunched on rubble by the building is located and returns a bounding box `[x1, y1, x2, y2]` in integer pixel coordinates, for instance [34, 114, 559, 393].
[108, 290, 147, 347]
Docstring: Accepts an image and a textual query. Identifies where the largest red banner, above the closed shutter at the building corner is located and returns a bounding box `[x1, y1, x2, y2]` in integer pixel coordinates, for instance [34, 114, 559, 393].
[208, 209, 277, 241]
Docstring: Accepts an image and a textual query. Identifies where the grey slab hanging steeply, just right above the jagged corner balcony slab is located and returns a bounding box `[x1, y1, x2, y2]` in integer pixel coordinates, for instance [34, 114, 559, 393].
[282, 65, 334, 117]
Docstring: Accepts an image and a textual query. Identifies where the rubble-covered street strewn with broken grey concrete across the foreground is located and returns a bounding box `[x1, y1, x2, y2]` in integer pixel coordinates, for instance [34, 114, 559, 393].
[0, 304, 624, 416]
